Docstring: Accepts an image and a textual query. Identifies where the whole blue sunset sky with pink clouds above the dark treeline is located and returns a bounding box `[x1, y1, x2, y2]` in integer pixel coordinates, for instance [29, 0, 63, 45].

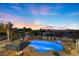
[0, 3, 79, 29]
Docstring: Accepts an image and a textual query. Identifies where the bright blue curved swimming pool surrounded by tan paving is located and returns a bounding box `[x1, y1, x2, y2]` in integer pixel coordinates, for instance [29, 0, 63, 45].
[29, 40, 64, 52]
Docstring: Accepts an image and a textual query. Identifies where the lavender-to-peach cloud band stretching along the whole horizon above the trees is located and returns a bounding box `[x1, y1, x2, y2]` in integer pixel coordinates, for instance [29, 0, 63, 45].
[0, 13, 79, 30]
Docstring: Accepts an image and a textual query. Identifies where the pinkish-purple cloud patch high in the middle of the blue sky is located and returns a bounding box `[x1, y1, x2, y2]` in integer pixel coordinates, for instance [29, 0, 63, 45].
[28, 5, 59, 15]
